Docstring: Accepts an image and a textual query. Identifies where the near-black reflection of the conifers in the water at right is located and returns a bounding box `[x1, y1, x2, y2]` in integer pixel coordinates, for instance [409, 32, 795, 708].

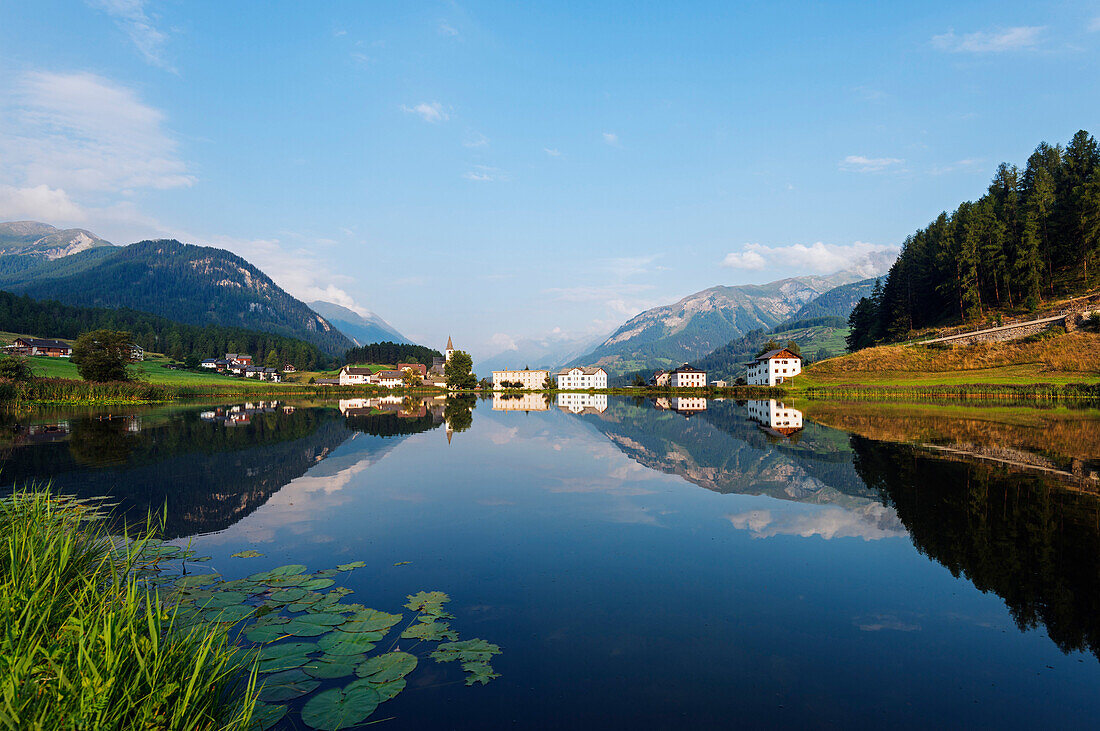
[851, 436, 1100, 656]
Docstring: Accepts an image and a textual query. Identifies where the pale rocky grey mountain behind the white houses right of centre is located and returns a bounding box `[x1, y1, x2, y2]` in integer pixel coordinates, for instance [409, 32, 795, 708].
[574, 272, 860, 374]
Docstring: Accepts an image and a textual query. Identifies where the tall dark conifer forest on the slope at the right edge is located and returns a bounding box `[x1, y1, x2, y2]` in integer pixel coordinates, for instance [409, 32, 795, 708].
[847, 130, 1100, 351]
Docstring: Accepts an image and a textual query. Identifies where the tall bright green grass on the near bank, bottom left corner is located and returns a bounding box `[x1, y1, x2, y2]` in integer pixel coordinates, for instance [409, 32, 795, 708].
[0, 492, 255, 730]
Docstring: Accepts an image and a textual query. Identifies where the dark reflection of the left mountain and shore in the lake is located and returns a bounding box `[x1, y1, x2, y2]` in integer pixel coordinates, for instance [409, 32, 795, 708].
[0, 401, 443, 538]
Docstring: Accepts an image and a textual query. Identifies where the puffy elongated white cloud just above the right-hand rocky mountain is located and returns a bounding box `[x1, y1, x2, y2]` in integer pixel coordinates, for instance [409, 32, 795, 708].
[722, 241, 898, 277]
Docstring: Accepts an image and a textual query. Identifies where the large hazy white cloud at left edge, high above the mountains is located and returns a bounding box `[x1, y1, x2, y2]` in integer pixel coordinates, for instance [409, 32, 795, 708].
[0, 71, 195, 195]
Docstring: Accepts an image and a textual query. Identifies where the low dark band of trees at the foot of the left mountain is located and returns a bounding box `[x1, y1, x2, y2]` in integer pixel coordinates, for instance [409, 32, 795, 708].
[0, 291, 337, 370]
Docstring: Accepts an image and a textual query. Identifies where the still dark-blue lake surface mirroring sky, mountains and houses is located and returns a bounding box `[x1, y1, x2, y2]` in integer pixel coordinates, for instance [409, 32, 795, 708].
[0, 396, 1100, 729]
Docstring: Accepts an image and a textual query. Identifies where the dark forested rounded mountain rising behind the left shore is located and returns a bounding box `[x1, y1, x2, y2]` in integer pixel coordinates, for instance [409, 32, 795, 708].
[0, 240, 354, 355]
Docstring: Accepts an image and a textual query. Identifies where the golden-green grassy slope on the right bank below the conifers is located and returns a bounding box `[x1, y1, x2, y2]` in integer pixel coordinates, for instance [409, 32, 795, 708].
[793, 331, 1100, 388]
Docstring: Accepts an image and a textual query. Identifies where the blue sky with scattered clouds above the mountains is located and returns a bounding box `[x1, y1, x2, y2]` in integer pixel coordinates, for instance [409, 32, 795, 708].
[0, 0, 1100, 357]
